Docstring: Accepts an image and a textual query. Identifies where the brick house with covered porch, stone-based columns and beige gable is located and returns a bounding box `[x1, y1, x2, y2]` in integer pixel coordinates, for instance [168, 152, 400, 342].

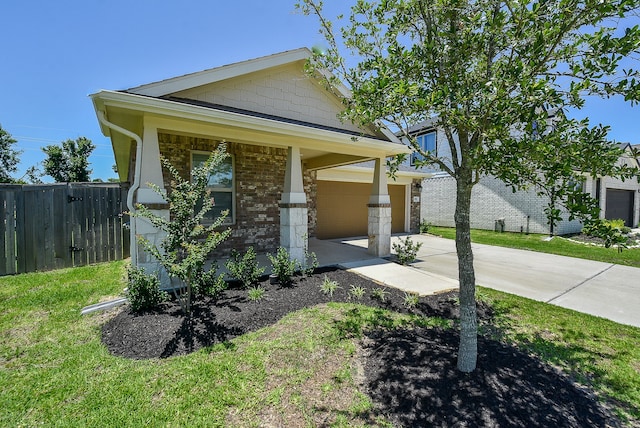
[91, 48, 416, 280]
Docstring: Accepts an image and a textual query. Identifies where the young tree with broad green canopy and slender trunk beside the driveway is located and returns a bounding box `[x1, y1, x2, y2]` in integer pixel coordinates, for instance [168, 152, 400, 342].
[298, 0, 640, 372]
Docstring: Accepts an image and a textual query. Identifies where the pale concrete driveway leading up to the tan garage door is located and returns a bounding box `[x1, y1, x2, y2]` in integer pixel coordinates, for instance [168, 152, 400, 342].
[343, 235, 640, 327]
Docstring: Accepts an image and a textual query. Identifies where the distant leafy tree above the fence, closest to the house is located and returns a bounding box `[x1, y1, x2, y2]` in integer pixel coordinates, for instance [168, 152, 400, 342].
[42, 137, 96, 183]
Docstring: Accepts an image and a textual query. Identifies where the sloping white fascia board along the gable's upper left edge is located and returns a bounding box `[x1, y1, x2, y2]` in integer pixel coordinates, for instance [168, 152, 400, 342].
[128, 48, 312, 97]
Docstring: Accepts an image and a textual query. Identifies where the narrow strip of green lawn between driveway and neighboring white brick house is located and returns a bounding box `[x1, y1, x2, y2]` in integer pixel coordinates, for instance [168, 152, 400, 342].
[429, 226, 640, 267]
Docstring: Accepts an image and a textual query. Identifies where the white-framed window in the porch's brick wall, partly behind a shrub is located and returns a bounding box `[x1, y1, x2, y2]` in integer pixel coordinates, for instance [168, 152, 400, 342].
[191, 152, 235, 224]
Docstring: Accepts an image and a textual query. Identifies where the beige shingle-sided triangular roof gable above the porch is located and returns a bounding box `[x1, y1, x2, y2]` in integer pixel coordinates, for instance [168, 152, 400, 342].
[125, 48, 389, 139]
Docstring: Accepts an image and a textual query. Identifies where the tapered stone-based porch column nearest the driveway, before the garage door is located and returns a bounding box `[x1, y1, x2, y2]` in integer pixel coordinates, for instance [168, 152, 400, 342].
[367, 158, 391, 257]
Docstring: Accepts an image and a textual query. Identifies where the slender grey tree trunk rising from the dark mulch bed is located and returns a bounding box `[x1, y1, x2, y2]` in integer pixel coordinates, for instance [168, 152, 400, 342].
[455, 174, 478, 373]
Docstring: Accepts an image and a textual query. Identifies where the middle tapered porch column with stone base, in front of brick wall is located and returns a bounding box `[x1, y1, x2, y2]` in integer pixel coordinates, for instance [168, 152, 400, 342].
[280, 147, 308, 263]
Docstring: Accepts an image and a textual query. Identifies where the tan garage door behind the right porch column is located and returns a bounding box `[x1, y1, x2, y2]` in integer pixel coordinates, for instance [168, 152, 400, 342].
[316, 180, 405, 239]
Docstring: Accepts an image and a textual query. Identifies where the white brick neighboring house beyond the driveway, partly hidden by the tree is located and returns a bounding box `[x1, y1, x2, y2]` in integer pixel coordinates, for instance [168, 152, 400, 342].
[410, 121, 640, 235]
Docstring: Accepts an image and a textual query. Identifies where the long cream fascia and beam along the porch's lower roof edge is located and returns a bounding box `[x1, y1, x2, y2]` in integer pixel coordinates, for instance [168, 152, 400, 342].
[91, 91, 411, 158]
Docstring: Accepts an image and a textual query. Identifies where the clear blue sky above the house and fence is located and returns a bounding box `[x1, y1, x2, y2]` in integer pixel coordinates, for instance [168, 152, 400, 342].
[0, 0, 640, 181]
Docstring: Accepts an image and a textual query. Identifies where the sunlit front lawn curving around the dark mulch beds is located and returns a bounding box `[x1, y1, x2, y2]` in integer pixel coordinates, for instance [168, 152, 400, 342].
[0, 262, 640, 427]
